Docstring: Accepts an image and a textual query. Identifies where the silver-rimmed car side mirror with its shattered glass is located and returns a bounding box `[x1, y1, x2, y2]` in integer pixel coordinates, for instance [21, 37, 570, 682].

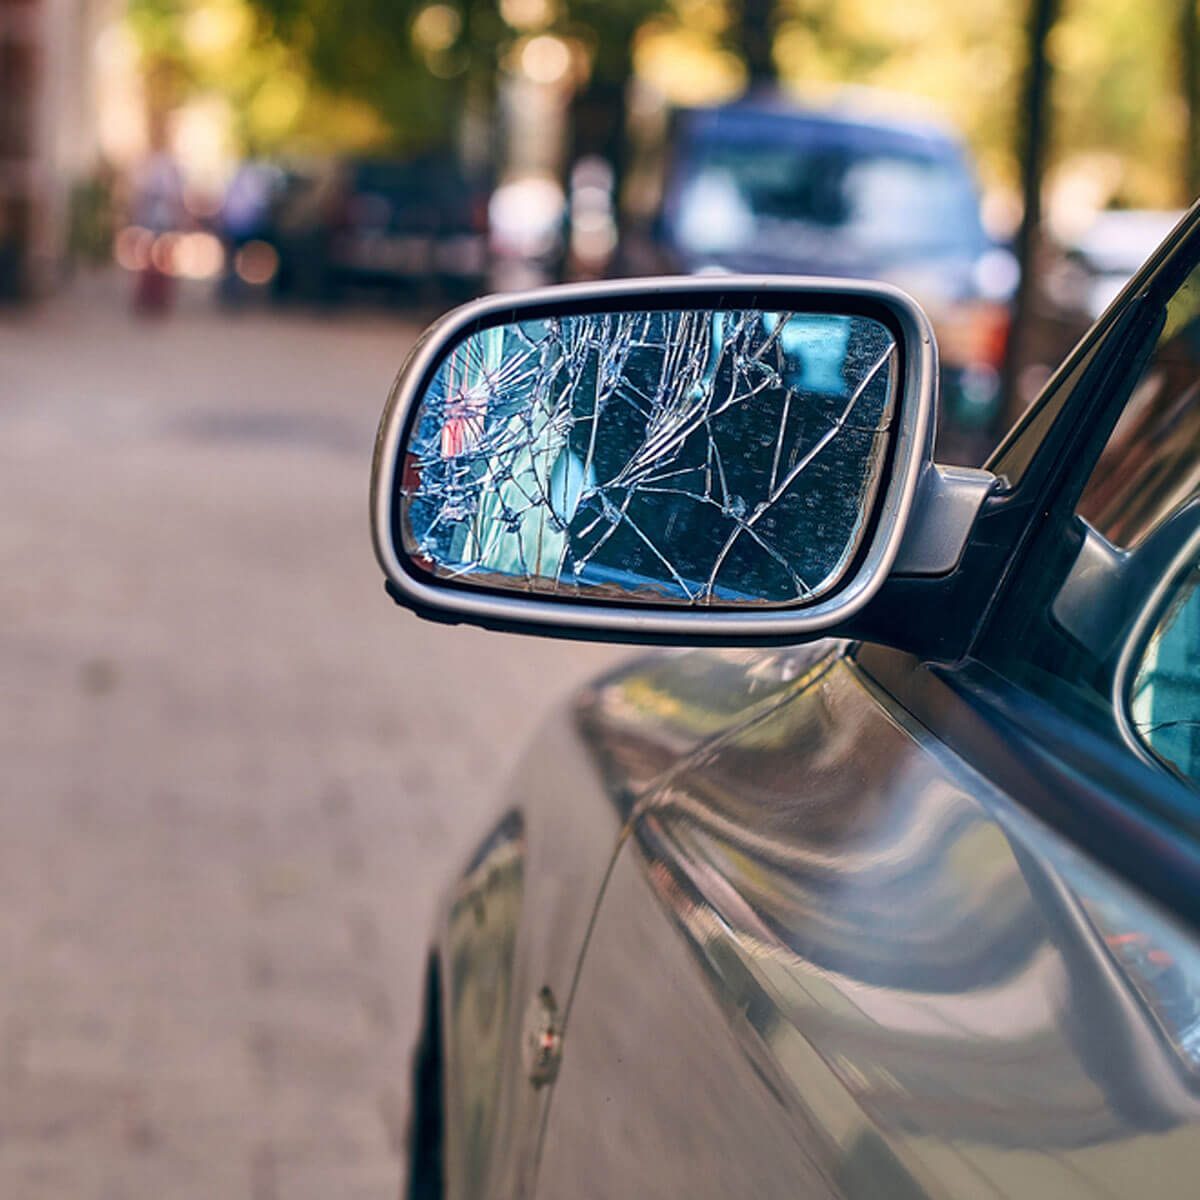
[372, 276, 982, 643]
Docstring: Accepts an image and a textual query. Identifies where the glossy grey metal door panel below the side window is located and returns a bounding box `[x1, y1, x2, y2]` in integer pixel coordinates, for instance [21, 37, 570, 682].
[538, 658, 1200, 1200]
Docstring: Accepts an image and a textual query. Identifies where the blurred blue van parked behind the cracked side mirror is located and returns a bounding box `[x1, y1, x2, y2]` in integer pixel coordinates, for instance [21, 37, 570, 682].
[622, 98, 1018, 464]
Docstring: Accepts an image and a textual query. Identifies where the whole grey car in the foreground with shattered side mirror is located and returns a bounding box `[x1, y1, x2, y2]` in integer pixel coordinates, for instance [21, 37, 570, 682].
[372, 206, 1200, 1200]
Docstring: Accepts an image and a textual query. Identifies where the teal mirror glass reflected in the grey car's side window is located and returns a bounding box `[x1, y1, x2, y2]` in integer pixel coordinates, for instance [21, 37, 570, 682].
[1129, 568, 1200, 785]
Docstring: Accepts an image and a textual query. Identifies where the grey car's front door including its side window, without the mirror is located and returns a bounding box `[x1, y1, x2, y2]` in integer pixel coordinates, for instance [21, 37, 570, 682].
[538, 211, 1200, 1198]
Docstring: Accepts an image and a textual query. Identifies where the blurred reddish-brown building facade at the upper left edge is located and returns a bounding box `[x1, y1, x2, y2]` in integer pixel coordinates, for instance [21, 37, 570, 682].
[0, 0, 113, 301]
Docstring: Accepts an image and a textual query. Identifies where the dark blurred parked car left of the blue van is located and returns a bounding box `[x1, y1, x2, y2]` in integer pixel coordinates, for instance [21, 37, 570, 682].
[274, 155, 488, 304]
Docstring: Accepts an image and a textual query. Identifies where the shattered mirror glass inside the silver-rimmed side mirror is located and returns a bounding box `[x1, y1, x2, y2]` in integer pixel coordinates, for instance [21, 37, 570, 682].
[400, 310, 899, 607]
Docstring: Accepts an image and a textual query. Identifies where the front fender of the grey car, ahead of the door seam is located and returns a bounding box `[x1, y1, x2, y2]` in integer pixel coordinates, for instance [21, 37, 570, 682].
[436, 642, 841, 1198]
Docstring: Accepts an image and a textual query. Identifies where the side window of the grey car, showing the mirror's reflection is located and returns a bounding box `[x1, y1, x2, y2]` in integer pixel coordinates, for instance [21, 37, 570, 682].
[978, 250, 1200, 816]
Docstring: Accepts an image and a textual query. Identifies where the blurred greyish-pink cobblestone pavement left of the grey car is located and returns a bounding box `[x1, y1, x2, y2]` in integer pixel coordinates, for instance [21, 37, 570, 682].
[0, 278, 618, 1200]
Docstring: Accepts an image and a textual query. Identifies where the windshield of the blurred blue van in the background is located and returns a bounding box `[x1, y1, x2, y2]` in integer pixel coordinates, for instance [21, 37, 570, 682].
[677, 142, 982, 262]
